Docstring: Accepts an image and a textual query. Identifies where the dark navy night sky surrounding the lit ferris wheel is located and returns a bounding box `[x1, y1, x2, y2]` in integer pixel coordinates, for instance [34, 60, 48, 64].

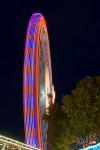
[0, 0, 100, 141]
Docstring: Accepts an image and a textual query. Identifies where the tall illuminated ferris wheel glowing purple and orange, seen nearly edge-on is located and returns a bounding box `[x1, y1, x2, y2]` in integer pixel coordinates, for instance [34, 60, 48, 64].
[23, 13, 54, 150]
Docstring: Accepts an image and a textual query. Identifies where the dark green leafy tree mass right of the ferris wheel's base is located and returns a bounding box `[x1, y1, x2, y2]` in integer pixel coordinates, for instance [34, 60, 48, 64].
[44, 77, 100, 150]
